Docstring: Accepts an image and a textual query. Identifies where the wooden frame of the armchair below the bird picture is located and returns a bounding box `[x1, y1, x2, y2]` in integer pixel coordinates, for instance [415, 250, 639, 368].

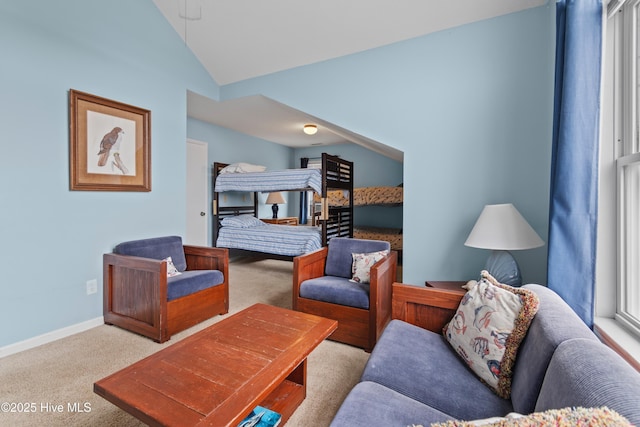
[103, 245, 229, 343]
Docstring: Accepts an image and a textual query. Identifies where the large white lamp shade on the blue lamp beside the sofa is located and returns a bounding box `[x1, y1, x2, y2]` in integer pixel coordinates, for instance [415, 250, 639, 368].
[464, 203, 544, 251]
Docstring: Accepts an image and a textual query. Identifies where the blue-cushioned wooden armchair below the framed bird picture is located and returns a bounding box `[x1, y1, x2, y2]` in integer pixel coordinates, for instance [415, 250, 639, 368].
[103, 236, 229, 342]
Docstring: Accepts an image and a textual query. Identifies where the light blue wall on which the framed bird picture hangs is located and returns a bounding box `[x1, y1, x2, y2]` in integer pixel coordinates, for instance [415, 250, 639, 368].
[0, 0, 219, 347]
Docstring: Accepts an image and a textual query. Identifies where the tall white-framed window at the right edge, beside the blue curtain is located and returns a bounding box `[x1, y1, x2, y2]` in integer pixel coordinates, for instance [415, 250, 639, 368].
[614, 0, 640, 335]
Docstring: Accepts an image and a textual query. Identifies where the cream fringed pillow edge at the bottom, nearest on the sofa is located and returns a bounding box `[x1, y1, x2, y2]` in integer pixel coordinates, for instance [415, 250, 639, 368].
[428, 407, 633, 427]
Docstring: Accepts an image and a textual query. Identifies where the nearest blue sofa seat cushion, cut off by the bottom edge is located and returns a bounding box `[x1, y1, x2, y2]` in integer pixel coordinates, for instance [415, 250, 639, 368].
[331, 381, 452, 427]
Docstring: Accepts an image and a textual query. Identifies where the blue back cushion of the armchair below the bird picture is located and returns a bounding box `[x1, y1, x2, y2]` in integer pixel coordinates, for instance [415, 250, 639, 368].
[113, 236, 187, 272]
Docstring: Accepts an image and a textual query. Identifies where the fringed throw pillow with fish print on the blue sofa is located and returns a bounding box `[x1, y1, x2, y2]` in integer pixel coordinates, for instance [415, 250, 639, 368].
[443, 270, 539, 399]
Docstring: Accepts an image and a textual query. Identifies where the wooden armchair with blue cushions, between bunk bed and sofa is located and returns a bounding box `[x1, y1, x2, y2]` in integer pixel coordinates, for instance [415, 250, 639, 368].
[293, 237, 398, 351]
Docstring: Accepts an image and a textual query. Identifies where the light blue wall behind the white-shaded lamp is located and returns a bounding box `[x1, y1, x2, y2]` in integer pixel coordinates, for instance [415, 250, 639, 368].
[221, 5, 554, 284]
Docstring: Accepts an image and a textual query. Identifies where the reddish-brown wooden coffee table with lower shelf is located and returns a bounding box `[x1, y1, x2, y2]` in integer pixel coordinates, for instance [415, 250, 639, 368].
[93, 304, 338, 426]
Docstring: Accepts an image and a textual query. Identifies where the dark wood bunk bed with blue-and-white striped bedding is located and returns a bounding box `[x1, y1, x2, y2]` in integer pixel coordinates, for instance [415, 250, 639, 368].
[213, 153, 353, 258]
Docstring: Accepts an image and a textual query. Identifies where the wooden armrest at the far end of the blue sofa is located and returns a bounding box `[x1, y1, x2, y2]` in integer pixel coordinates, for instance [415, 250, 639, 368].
[392, 283, 463, 333]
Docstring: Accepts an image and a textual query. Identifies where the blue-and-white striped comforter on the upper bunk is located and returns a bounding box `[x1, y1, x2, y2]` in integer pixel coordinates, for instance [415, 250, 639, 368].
[214, 169, 322, 193]
